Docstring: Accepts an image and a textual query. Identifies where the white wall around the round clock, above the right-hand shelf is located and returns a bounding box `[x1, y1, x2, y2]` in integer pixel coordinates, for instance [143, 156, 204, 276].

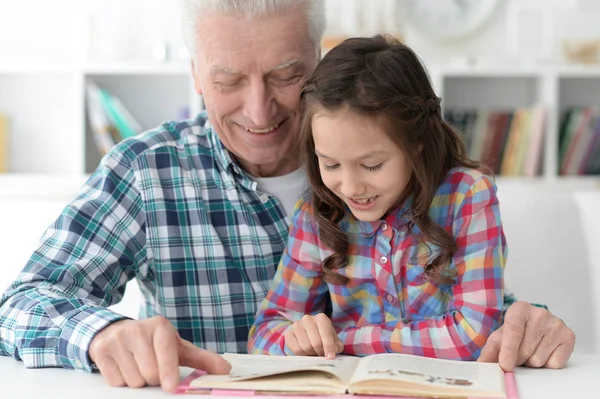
[326, 0, 600, 64]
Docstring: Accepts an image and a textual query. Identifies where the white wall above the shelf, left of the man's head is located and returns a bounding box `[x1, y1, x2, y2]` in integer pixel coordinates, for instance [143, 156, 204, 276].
[0, 0, 183, 66]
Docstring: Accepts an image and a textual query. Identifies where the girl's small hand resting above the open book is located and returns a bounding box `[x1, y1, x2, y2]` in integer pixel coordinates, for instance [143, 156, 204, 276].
[284, 313, 344, 359]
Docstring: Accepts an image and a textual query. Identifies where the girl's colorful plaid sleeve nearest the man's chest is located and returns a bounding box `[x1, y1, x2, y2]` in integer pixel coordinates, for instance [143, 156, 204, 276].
[248, 200, 329, 355]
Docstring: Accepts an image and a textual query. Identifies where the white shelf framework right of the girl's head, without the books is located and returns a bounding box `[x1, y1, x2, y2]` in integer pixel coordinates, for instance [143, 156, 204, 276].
[428, 66, 600, 189]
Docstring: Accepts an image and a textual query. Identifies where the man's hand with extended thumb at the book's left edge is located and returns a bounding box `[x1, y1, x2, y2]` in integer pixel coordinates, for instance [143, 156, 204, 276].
[89, 316, 231, 392]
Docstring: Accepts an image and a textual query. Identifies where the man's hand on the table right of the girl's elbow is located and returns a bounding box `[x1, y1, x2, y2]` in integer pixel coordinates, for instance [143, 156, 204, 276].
[478, 302, 575, 371]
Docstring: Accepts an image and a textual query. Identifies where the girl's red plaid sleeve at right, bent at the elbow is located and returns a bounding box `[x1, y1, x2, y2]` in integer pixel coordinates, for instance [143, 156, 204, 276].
[339, 173, 507, 360]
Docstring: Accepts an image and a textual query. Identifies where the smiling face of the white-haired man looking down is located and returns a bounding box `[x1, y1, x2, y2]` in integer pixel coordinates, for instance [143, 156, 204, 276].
[193, 9, 317, 176]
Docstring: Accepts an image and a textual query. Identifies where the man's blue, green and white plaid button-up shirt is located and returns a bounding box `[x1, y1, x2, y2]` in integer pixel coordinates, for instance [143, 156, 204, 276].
[0, 114, 524, 371]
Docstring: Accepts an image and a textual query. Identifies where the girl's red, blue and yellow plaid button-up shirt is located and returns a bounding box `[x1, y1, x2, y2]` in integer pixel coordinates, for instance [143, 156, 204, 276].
[248, 168, 507, 360]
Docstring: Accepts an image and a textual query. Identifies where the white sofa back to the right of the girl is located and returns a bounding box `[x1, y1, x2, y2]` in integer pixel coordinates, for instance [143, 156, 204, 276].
[498, 184, 600, 353]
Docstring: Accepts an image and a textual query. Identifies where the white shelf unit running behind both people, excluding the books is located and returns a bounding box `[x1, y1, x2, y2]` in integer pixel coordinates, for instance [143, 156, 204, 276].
[0, 63, 600, 187]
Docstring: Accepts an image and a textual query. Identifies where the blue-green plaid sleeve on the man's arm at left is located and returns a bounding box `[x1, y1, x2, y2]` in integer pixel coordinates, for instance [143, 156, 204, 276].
[0, 146, 146, 371]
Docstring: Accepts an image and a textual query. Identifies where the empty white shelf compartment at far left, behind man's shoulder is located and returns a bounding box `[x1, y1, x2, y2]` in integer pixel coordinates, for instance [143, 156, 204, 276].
[0, 70, 85, 174]
